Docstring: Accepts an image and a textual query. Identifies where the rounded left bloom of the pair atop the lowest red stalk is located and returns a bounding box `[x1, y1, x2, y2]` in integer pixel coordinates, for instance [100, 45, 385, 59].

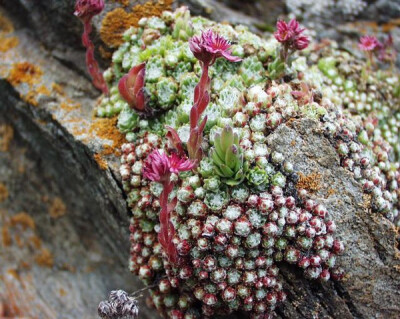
[143, 150, 170, 182]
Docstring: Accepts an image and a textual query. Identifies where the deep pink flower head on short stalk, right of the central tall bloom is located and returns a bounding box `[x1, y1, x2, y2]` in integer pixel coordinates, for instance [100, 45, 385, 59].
[274, 19, 310, 62]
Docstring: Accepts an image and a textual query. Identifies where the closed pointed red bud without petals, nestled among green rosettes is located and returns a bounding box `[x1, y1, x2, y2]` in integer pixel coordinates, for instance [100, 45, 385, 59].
[118, 63, 146, 112]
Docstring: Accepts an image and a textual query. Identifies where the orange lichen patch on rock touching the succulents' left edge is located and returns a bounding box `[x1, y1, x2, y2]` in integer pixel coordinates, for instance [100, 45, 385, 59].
[89, 117, 125, 156]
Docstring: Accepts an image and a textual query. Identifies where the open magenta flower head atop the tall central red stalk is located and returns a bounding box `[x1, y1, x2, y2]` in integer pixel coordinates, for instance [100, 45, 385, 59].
[189, 29, 241, 65]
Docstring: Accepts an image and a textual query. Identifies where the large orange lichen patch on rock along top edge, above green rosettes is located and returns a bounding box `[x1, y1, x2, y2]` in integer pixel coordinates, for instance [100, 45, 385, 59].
[100, 0, 173, 47]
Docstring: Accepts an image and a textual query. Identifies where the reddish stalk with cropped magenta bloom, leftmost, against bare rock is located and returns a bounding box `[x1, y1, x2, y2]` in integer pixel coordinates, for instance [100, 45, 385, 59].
[74, 0, 108, 94]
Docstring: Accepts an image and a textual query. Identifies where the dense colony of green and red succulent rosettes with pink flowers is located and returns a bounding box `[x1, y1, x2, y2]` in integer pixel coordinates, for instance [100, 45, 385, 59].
[78, 2, 400, 319]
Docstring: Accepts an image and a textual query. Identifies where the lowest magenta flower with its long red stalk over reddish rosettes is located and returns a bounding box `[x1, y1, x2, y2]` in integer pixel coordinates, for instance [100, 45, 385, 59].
[143, 150, 194, 264]
